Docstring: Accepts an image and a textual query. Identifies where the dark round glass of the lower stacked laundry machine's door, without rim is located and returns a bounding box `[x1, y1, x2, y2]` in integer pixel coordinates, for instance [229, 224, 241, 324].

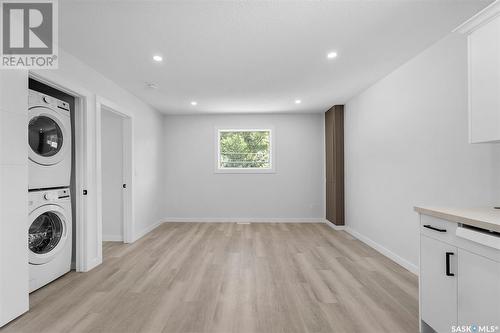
[28, 212, 64, 254]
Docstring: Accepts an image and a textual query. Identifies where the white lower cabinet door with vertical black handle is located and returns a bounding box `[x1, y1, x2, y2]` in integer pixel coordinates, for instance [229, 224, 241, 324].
[420, 235, 457, 333]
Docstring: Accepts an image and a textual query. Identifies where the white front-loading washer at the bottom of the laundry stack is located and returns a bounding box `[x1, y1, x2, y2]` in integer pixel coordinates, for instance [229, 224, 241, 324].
[28, 188, 72, 292]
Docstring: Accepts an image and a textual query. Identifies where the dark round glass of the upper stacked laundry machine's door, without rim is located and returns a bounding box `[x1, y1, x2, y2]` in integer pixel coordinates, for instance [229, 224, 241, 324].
[28, 116, 63, 157]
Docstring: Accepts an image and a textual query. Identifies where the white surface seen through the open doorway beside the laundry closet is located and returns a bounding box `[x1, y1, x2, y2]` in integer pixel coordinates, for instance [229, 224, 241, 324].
[101, 108, 123, 241]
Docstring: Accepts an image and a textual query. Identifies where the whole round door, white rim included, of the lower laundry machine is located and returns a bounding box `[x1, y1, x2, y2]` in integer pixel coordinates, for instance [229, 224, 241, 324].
[28, 205, 67, 265]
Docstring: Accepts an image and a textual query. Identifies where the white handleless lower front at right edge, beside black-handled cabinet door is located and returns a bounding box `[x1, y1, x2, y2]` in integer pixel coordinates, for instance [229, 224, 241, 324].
[458, 249, 500, 326]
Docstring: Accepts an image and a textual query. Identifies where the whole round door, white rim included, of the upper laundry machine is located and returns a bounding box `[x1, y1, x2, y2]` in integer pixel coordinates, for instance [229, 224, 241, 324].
[28, 106, 70, 165]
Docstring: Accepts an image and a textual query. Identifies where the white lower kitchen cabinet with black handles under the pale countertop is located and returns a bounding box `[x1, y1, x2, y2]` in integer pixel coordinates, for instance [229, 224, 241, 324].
[417, 208, 500, 333]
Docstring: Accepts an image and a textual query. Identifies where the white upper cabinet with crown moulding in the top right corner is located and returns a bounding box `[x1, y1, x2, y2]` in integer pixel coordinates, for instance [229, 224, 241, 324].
[455, 0, 500, 143]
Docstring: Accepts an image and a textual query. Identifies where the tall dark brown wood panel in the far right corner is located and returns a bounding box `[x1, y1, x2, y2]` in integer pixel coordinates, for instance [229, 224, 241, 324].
[325, 105, 345, 225]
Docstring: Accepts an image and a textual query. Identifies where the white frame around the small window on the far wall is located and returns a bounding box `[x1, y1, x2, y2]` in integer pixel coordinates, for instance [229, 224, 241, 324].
[215, 127, 276, 173]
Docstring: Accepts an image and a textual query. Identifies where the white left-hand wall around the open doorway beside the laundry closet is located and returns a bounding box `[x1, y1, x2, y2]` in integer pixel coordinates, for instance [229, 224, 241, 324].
[35, 50, 164, 268]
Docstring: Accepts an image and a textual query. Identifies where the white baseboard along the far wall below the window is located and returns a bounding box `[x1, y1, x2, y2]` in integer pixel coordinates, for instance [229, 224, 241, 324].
[163, 217, 325, 223]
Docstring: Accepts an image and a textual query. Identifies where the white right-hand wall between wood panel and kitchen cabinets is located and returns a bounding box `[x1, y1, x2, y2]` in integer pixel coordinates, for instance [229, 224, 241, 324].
[345, 35, 499, 270]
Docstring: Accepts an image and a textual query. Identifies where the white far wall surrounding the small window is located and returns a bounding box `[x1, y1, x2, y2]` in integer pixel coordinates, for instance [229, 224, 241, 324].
[163, 114, 324, 221]
